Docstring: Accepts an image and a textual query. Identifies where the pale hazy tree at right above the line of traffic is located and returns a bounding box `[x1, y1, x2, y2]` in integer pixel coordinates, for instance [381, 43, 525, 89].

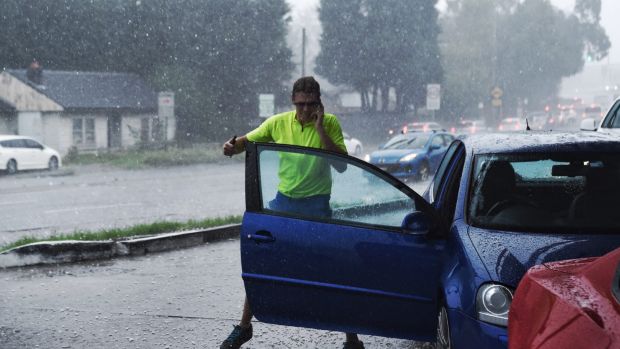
[440, 0, 609, 118]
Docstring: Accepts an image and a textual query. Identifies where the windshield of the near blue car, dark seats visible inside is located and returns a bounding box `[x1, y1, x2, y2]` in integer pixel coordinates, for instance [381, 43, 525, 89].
[469, 153, 620, 232]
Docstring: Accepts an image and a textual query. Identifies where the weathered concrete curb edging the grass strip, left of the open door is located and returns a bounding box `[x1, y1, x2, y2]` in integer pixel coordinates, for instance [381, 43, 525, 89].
[0, 224, 241, 268]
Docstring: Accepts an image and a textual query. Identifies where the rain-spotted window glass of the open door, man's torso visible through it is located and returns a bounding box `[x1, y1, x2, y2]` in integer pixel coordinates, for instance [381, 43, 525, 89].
[254, 144, 416, 228]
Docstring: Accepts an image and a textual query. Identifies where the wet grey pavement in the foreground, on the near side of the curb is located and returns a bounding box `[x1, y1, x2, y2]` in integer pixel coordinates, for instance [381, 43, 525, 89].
[0, 240, 430, 349]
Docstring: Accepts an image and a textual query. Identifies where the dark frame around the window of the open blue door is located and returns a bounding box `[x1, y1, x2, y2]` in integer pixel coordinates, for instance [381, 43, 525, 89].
[245, 141, 438, 234]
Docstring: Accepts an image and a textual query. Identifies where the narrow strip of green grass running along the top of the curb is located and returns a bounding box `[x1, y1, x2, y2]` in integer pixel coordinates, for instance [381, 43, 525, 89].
[0, 216, 241, 252]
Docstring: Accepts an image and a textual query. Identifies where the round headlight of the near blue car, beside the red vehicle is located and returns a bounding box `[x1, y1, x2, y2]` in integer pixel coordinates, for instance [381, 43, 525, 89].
[476, 284, 513, 327]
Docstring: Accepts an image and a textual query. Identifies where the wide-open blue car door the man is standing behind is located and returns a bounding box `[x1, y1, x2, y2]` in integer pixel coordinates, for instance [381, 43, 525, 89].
[241, 143, 444, 340]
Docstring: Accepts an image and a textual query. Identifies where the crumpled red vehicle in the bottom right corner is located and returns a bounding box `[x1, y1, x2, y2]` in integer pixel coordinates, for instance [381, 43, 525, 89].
[508, 248, 620, 349]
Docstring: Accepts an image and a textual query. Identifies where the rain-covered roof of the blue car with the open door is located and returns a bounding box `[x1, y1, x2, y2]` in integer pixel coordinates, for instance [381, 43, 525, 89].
[461, 131, 620, 154]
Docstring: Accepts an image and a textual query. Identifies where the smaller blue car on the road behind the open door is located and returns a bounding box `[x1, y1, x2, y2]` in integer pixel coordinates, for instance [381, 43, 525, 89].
[365, 131, 454, 181]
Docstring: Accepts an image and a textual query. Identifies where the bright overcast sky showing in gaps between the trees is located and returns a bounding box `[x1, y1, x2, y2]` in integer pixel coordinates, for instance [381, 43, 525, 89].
[288, 0, 620, 68]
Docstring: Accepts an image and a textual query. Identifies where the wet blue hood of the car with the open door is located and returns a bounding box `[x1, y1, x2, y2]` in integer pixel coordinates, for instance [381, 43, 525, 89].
[469, 227, 620, 287]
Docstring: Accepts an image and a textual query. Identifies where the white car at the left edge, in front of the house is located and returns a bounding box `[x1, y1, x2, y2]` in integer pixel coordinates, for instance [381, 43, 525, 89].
[0, 135, 61, 174]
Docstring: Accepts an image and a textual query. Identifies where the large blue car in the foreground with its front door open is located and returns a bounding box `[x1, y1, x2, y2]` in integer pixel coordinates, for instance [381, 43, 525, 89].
[240, 132, 620, 348]
